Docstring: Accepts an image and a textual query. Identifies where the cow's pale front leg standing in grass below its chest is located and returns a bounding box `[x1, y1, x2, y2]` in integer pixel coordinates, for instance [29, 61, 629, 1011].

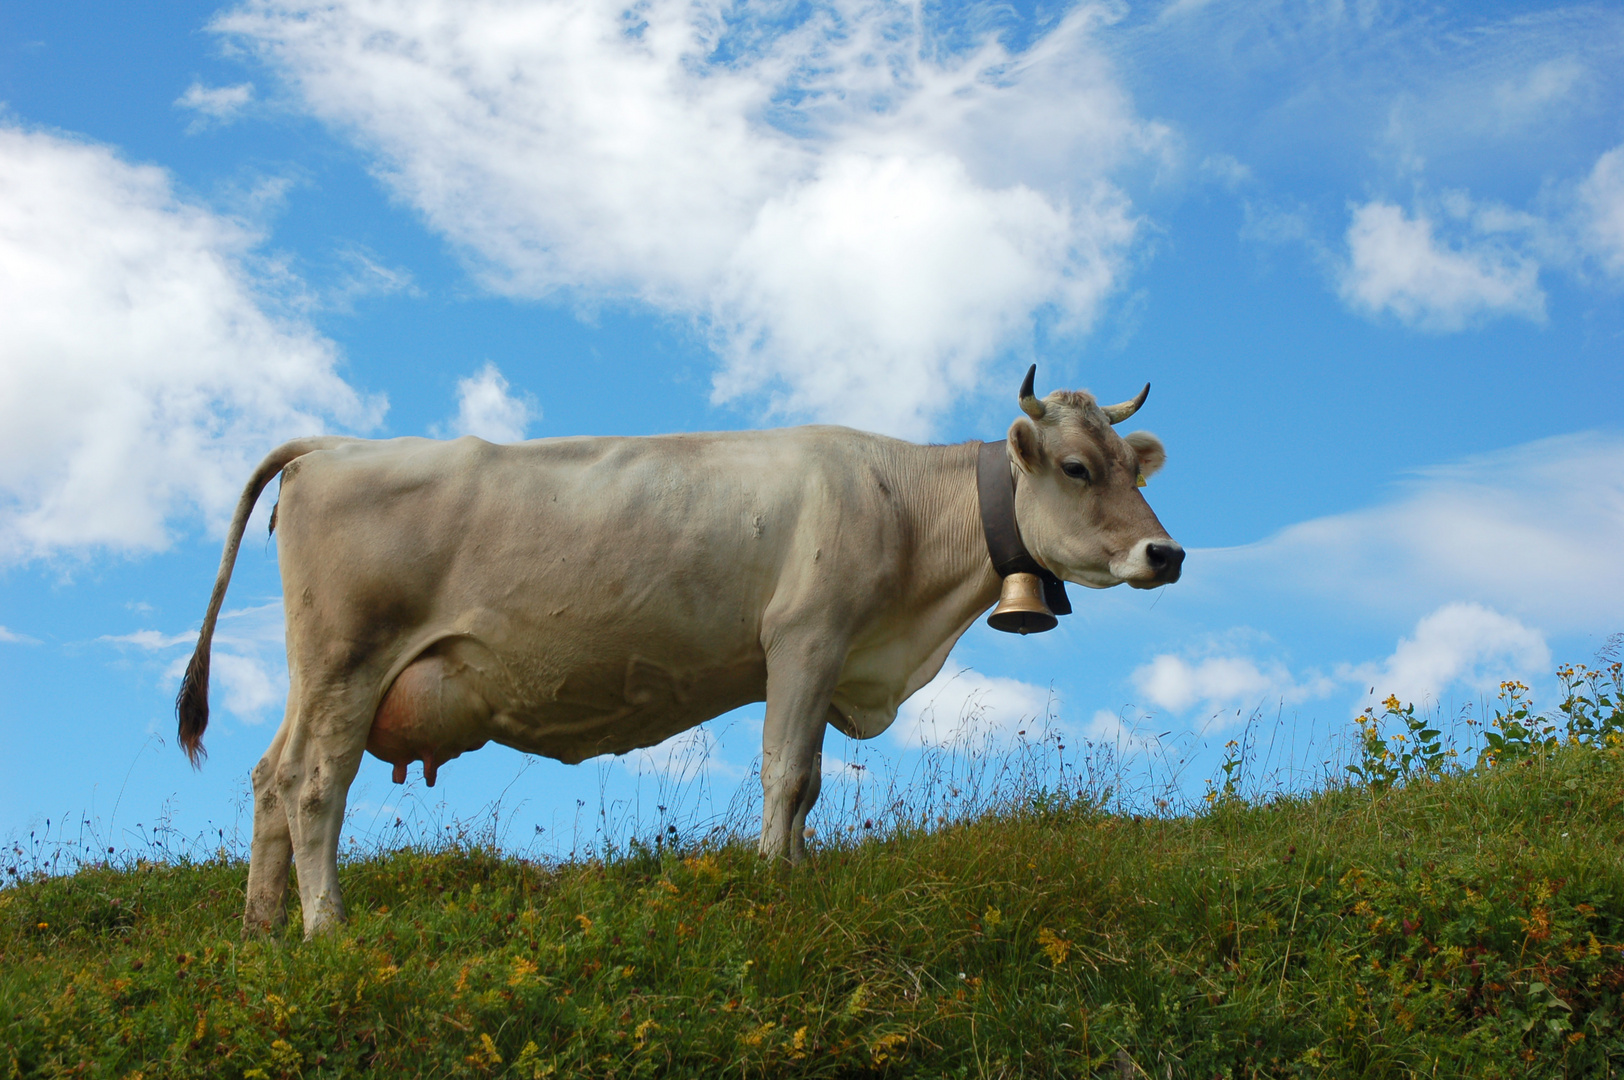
[760, 639, 840, 862]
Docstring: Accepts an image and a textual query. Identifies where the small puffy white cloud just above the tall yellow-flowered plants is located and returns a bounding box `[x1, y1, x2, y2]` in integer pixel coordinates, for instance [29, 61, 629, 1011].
[1346, 603, 1551, 705]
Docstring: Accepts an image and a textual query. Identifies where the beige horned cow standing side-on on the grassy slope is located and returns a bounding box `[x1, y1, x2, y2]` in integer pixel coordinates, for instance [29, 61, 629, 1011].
[175, 372, 1184, 937]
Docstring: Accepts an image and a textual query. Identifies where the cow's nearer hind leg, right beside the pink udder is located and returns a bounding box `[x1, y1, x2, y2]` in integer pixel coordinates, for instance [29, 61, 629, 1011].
[276, 687, 374, 939]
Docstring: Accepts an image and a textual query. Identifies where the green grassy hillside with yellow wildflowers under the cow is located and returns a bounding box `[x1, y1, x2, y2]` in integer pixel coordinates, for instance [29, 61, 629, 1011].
[0, 669, 1624, 1078]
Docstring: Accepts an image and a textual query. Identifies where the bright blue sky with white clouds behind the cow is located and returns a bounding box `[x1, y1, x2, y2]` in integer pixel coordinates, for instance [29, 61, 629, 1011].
[0, 0, 1624, 846]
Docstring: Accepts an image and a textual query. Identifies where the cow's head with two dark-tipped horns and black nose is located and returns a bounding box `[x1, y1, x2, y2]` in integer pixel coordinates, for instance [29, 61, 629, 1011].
[1009, 367, 1184, 590]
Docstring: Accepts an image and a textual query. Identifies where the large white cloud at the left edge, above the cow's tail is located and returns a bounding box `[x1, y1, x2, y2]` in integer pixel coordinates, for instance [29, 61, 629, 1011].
[0, 127, 382, 562]
